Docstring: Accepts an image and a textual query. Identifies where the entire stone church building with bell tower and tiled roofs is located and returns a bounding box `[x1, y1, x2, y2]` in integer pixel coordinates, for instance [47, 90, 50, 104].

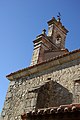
[1, 16, 80, 120]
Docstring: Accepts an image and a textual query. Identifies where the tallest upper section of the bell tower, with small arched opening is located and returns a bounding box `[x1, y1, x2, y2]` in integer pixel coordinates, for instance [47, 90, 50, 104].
[48, 16, 68, 49]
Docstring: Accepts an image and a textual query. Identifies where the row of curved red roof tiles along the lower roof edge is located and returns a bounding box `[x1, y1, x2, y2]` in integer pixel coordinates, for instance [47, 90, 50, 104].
[21, 104, 80, 118]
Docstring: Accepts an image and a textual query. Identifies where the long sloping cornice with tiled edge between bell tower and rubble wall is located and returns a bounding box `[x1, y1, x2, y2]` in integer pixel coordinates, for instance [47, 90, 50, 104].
[6, 49, 80, 81]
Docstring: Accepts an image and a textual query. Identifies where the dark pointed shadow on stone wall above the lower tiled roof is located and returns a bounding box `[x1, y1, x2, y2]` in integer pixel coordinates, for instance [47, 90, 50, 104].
[36, 81, 73, 109]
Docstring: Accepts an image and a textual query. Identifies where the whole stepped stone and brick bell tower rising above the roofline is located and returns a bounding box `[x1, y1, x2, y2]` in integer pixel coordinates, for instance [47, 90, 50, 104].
[31, 16, 68, 66]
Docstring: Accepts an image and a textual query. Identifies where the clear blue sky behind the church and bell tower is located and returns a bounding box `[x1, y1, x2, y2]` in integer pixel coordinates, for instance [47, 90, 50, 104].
[0, 0, 80, 112]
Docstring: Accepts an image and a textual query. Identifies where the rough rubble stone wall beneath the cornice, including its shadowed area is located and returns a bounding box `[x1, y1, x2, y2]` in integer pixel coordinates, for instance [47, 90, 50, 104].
[2, 59, 80, 120]
